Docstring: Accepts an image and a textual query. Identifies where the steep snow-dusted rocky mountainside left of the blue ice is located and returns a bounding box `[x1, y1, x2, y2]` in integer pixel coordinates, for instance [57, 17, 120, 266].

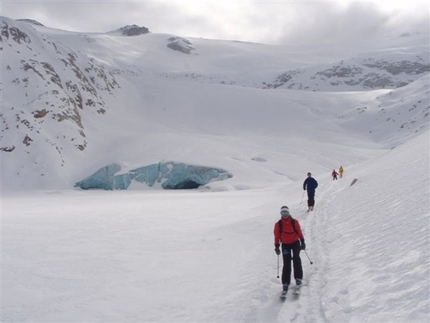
[0, 19, 120, 163]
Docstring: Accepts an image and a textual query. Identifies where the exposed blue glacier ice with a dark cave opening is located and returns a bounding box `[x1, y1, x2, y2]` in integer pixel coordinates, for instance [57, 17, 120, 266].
[75, 162, 233, 190]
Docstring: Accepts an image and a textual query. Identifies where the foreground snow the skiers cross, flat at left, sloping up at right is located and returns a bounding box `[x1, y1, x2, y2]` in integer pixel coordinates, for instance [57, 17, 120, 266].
[2, 132, 430, 322]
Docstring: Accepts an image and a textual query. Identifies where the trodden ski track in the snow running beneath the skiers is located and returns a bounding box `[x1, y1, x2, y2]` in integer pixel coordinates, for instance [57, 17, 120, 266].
[252, 182, 343, 323]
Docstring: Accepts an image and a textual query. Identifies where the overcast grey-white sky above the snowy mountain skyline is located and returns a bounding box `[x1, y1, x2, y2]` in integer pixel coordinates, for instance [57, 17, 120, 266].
[1, 0, 429, 44]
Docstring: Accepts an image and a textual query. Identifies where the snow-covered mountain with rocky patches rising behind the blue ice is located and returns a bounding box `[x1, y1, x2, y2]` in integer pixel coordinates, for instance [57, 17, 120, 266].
[0, 17, 430, 188]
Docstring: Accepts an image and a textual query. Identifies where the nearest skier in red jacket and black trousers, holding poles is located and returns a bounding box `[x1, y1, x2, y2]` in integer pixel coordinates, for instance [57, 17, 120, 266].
[273, 206, 306, 297]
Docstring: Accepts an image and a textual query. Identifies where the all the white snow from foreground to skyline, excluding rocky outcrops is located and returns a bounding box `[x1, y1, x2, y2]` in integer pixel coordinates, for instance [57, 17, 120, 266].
[1, 18, 430, 323]
